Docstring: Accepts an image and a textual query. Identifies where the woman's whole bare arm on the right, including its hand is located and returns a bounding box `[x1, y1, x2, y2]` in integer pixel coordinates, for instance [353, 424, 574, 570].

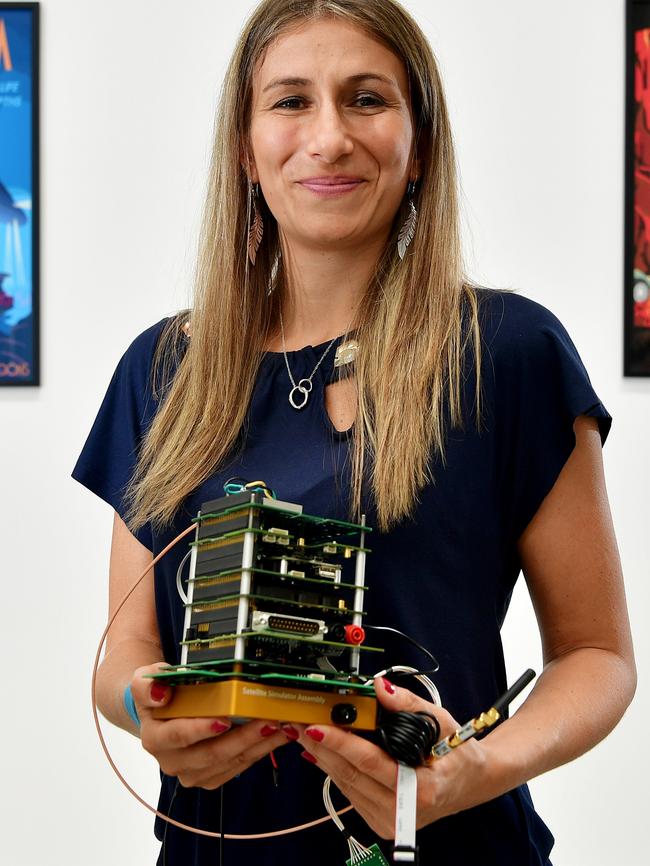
[292, 417, 636, 838]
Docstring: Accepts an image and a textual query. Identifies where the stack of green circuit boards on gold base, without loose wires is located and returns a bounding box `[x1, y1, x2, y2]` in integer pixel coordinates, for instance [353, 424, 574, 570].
[151, 491, 380, 728]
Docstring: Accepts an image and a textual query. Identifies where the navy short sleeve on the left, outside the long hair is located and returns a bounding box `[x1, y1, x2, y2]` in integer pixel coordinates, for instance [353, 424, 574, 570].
[72, 319, 168, 550]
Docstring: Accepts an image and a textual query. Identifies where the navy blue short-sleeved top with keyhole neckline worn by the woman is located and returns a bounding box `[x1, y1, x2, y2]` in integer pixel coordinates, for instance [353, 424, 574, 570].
[73, 290, 611, 866]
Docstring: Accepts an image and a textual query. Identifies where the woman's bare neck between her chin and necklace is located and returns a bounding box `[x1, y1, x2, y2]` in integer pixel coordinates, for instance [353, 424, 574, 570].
[268, 235, 381, 351]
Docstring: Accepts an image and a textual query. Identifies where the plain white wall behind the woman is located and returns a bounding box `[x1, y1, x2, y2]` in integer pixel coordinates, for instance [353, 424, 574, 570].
[0, 0, 650, 866]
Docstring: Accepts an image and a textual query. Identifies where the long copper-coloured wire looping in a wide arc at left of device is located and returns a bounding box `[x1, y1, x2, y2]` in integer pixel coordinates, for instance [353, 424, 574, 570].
[90, 523, 352, 840]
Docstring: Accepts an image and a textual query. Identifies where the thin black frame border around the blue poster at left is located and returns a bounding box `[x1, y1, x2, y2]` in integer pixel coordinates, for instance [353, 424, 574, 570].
[0, 2, 41, 388]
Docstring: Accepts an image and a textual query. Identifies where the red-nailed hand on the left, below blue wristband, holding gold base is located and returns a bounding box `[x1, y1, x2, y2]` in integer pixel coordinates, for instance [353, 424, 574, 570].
[131, 662, 289, 790]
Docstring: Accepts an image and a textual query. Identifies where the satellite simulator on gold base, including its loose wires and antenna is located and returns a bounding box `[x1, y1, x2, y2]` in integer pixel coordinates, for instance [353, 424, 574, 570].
[92, 479, 535, 866]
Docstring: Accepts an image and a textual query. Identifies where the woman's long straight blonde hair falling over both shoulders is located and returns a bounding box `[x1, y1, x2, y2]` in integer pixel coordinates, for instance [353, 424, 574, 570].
[127, 0, 480, 530]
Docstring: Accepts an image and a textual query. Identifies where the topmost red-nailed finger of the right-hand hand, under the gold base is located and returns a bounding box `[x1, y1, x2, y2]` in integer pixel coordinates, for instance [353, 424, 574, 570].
[299, 725, 397, 794]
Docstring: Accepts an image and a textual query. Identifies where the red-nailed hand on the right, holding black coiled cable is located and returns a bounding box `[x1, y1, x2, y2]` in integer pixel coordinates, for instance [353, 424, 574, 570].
[293, 679, 492, 839]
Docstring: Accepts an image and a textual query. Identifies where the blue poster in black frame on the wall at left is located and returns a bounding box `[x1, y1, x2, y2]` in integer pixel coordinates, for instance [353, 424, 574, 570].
[0, 2, 40, 385]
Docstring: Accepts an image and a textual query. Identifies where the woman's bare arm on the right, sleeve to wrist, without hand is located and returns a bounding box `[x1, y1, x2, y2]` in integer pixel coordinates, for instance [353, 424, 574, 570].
[485, 416, 636, 787]
